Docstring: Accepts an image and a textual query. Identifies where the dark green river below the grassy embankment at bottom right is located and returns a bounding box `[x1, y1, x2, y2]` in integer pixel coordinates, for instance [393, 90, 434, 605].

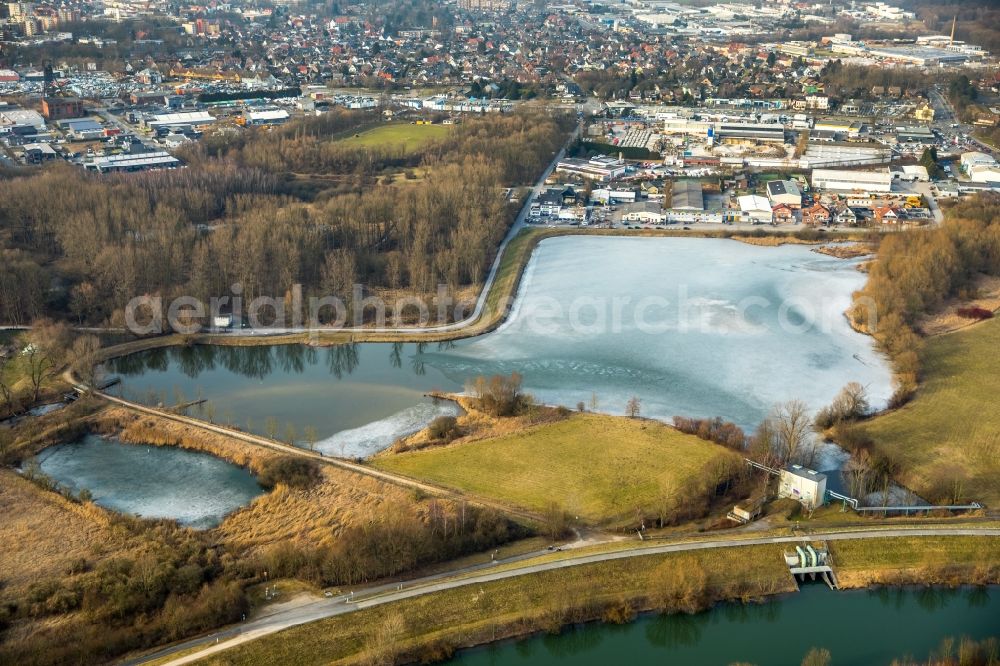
[448, 584, 1000, 666]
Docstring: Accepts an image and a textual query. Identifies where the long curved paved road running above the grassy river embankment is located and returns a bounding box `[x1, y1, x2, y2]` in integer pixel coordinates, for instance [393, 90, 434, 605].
[133, 527, 1000, 666]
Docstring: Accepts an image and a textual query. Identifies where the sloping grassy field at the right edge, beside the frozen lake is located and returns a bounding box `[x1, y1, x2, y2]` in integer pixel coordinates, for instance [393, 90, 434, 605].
[865, 318, 1000, 507]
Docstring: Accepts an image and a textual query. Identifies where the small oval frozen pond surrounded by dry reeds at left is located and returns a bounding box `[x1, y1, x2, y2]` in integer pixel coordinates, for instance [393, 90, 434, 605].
[37, 435, 264, 529]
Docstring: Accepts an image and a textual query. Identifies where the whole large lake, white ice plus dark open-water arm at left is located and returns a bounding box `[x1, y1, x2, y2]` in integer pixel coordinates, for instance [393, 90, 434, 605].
[108, 236, 892, 456]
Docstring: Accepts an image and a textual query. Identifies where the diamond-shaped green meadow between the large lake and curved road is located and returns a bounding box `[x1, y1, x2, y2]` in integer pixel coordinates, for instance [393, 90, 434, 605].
[373, 414, 738, 523]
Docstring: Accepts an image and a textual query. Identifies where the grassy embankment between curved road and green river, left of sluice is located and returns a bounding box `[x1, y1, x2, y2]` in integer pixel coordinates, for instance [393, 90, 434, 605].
[207, 546, 794, 665]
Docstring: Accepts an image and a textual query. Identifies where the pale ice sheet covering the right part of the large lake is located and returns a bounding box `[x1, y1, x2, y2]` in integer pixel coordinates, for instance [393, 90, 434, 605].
[421, 237, 892, 428]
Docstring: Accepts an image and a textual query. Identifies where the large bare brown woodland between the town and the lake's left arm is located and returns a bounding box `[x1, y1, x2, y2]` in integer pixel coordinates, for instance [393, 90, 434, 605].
[0, 110, 572, 324]
